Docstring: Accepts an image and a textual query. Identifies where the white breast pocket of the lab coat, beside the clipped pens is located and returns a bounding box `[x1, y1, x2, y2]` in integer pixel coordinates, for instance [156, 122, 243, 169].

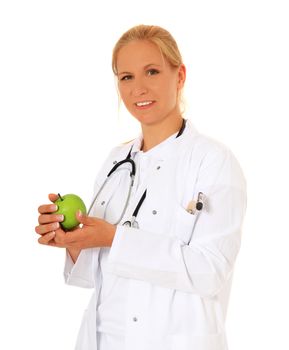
[172, 205, 197, 244]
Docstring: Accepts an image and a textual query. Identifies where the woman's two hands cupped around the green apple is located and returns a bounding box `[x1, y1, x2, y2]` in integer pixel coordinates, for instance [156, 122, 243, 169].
[35, 194, 116, 249]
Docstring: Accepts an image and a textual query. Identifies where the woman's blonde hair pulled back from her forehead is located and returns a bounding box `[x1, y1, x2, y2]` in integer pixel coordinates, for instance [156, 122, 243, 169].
[112, 24, 184, 114]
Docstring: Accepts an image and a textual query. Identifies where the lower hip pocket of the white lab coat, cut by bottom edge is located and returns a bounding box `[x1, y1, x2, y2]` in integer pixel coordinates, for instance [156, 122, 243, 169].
[171, 333, 227, 350]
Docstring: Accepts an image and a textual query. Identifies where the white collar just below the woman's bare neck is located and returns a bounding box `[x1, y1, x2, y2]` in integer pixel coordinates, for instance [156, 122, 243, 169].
[129, 118, 198, 159]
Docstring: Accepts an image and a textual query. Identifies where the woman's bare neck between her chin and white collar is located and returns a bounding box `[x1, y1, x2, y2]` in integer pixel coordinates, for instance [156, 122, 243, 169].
[141, 115, 183, 152]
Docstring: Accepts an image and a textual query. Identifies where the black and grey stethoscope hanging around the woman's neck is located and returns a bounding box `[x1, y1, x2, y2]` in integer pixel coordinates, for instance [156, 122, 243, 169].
[88, 118, 186, 228]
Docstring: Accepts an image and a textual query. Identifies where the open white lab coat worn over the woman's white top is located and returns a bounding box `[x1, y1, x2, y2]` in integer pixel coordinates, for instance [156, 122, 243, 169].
[64, 120, 246, 350]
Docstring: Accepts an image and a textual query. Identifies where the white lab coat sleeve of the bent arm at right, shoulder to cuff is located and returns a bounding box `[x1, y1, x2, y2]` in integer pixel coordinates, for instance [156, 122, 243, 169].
[109, 146, 246, 296]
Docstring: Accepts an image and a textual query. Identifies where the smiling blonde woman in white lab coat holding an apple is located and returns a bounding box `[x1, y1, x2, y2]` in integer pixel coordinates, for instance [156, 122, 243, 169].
[36, 25, 246, 350]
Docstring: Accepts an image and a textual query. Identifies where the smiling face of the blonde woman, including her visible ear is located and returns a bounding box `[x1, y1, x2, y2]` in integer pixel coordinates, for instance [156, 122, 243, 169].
[117, 40, 186, 124]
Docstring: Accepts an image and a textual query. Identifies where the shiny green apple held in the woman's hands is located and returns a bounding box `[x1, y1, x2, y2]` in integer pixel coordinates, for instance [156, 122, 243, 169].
[54, 193, 86, 231]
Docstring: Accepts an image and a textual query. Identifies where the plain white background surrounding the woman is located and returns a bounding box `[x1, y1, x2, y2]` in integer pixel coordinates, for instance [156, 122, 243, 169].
[0, 0, 289, 350]
